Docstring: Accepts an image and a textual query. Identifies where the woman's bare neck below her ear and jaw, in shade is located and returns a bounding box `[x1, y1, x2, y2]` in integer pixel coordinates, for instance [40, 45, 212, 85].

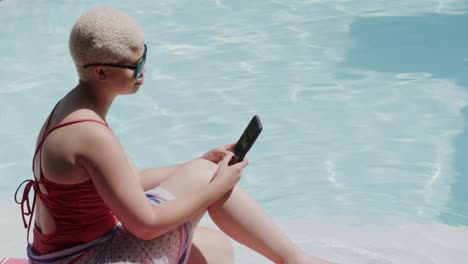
[74, 80, 115, 120]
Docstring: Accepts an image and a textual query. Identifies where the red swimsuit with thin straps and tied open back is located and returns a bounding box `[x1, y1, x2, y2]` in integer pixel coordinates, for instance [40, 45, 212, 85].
[15, 105, 118, 255]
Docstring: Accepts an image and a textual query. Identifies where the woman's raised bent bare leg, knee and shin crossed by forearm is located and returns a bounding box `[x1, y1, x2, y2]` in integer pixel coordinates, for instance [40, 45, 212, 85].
[161, 160, 327, 264]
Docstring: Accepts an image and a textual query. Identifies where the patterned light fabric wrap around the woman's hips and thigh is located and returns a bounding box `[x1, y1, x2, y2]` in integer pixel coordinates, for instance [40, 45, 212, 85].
[28, 187, 193, 264]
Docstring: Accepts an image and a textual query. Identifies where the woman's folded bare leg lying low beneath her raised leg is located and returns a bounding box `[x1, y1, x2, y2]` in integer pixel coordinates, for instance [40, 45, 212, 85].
[188, 227, 234, 264]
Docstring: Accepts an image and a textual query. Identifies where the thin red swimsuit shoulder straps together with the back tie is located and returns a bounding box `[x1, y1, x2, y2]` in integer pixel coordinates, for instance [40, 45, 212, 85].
[15, 101, 109, 244]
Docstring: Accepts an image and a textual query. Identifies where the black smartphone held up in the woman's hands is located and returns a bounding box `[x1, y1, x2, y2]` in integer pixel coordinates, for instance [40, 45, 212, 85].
[229, 115, 263, 165]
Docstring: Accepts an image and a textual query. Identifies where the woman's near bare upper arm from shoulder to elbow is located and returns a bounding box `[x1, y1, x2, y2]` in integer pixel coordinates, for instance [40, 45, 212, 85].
[77, 123, 153, 235]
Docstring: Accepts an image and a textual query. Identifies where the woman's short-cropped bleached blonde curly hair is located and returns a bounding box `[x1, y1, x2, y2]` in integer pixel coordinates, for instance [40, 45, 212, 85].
[69, 7, 144, 80]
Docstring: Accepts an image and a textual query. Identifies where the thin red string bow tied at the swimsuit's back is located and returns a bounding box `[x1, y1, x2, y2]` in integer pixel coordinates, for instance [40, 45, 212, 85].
[15, 180, 39, 244]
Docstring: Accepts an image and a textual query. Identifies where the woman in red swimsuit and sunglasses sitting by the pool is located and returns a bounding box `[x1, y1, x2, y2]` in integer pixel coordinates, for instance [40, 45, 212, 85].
[16, 7, 325, 263]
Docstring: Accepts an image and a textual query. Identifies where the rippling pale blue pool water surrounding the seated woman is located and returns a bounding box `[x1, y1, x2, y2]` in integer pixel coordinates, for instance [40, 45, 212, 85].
[0, 0, 468, 263]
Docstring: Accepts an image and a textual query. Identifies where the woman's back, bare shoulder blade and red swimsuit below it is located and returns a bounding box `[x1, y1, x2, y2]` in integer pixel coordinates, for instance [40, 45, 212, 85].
[28, 100, 118, 254]
